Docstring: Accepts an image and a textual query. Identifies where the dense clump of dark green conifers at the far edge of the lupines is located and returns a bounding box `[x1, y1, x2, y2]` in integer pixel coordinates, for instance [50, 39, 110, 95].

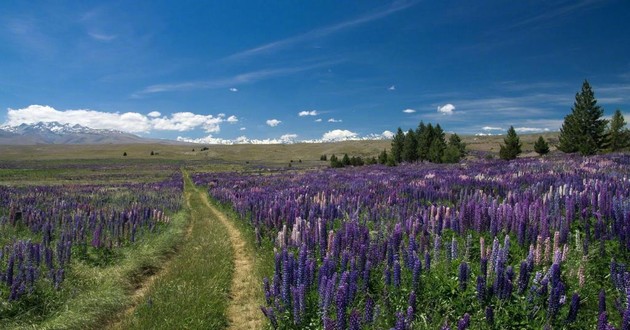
[390, 122, 466, 164]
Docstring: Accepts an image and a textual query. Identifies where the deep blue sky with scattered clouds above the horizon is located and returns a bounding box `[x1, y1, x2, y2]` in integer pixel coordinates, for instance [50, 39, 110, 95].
[0, 0, 630, 142]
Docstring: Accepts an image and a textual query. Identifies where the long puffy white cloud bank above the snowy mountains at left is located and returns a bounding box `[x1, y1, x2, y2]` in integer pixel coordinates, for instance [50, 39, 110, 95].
[5, 105, 238, 133]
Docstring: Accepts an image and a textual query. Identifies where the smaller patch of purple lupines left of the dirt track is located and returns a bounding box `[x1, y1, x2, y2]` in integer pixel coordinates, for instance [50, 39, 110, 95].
[0, 168, 183, 326]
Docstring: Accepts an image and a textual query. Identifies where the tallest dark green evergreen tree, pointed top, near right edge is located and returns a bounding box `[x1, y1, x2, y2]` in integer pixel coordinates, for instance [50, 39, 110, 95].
[558, 80, 607, 155]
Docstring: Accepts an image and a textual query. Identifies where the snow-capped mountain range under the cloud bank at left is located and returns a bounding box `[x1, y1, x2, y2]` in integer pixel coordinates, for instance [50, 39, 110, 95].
[0, 122, 155, 145]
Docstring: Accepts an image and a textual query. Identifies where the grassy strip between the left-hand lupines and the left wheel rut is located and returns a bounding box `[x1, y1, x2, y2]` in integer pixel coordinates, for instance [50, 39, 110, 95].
[0, 212, 189, 329]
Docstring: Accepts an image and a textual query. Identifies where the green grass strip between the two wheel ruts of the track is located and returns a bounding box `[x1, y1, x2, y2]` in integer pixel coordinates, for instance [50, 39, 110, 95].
[120, 174, 234, 329]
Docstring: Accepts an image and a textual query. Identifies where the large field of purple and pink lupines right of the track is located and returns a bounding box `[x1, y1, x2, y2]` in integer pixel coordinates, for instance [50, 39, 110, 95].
[195, 155, 630, 329]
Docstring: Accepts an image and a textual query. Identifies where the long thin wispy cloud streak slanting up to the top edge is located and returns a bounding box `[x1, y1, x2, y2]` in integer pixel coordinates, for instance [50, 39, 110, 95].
[225, 1, 418, 60]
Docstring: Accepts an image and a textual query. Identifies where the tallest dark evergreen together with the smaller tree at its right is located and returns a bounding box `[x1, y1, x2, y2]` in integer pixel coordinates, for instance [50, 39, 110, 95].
[558, 80, 630, 156]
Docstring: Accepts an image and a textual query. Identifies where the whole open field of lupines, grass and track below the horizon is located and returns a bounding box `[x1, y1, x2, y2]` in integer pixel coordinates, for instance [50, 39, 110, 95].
[0, 134, 630, 329]
